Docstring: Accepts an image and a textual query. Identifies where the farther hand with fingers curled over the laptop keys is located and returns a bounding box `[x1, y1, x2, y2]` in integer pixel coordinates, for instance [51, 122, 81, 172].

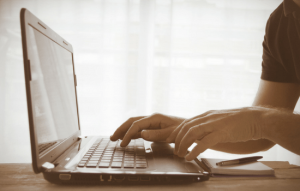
[110, 114, 185, 147]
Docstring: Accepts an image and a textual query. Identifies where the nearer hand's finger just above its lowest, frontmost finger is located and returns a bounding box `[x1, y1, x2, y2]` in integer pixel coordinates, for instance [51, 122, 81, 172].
[177, 124, 210, 157]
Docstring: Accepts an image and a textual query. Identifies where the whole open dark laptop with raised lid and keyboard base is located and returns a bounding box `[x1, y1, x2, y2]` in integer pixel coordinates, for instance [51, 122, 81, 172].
[20, 8, 209, 184]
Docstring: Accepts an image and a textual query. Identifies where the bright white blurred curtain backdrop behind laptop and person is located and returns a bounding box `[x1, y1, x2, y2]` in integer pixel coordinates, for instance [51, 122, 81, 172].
[0, 0, 300, 165]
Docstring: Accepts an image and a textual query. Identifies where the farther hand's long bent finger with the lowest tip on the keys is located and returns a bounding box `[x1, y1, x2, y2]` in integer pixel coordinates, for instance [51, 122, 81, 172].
[120, 114, 165, 147]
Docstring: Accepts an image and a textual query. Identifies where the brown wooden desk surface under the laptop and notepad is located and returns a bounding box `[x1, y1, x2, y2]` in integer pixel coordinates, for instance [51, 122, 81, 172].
[0, 163, 300, 191]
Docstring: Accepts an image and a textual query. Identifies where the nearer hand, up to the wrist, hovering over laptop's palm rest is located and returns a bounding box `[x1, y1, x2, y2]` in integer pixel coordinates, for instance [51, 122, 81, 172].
[166, 107, 272, 161]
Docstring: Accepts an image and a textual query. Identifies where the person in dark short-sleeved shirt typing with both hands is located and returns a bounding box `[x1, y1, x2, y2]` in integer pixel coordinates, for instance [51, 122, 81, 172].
[110, 0, 300, 161]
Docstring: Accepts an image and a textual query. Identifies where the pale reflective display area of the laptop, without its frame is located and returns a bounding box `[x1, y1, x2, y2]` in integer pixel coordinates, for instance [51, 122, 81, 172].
[27, 25, 79, 155]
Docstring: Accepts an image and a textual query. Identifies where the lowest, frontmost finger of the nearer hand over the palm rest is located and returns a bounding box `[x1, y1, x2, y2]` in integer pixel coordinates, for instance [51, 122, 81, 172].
[185, 132, 220, 161]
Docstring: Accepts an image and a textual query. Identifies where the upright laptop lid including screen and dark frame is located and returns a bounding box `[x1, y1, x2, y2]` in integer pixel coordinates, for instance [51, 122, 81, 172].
[20, 8, 80, 173]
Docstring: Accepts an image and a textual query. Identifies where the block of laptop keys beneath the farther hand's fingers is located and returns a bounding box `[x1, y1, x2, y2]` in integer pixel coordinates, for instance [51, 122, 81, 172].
[78, 138, 148, 169]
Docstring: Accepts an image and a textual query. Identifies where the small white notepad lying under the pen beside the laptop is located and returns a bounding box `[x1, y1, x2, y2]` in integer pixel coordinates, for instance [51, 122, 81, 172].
[198, 158, 274, 176]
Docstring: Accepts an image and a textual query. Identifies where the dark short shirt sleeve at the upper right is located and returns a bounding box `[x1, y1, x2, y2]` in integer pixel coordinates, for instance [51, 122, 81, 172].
[261, 0, 300, 84]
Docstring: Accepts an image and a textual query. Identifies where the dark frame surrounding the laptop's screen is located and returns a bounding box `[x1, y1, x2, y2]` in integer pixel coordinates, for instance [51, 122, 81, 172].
[20, 8, 81, 173]
